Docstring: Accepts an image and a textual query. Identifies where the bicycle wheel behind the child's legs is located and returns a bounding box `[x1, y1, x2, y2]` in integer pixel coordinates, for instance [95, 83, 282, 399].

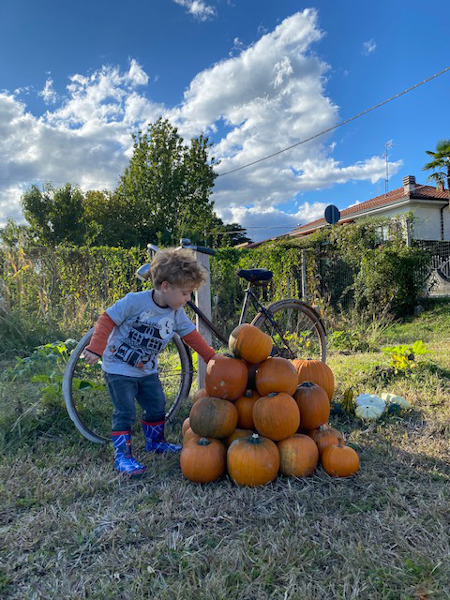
[62, 328, 193, 443]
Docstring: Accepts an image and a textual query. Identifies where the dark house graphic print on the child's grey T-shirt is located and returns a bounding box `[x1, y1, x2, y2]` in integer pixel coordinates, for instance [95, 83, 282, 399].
[108, 313, 174, 370]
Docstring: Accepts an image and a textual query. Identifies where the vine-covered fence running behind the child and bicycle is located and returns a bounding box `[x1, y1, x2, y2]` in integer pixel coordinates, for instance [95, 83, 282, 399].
[0, 242, 444, 342]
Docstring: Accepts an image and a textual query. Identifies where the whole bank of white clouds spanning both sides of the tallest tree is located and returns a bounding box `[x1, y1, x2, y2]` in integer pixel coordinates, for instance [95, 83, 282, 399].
[0, 11, 401, 239]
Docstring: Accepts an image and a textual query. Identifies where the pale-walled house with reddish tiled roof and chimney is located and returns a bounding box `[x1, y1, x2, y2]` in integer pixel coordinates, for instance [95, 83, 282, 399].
[288, 175, 450, 241]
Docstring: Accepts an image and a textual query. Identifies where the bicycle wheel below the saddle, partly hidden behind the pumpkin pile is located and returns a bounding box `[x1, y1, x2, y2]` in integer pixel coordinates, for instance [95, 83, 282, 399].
[252, 299, 327, 362]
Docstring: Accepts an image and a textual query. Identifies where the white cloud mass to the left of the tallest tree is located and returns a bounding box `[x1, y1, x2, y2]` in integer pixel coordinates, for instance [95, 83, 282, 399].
[0, 61, 163, 213]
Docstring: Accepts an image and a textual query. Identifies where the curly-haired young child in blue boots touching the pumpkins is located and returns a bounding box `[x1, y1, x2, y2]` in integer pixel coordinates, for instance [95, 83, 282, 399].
[84, 249, 215, 477]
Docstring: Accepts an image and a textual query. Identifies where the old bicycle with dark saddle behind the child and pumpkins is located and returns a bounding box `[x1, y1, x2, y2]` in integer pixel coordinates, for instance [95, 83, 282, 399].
[62, 239, 327, 443]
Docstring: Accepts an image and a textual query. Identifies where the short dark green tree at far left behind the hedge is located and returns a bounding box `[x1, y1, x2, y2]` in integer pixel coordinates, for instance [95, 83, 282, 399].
[22, 183, 87, 246]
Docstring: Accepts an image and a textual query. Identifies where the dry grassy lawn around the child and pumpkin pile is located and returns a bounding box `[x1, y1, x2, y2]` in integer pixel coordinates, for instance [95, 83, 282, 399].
[0, 302, 450, 600]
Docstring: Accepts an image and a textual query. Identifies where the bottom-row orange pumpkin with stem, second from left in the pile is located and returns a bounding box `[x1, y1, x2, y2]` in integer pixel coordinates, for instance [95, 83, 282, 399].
[227, 433, 280, 487]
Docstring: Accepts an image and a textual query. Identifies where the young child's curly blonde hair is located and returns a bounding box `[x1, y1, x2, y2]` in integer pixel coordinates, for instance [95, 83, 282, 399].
[150, 248, 206, 290]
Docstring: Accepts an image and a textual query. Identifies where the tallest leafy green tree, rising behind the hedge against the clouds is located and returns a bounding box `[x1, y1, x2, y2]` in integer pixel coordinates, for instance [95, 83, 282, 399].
[115, 119, 217, 247]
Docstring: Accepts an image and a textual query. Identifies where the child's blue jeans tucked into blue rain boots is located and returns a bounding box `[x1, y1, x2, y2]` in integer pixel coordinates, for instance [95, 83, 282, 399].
[104, 373, 166, 431]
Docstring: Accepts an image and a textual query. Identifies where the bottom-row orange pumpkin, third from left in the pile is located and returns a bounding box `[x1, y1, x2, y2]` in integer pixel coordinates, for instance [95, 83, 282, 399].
[278, 433, 319, 477]
